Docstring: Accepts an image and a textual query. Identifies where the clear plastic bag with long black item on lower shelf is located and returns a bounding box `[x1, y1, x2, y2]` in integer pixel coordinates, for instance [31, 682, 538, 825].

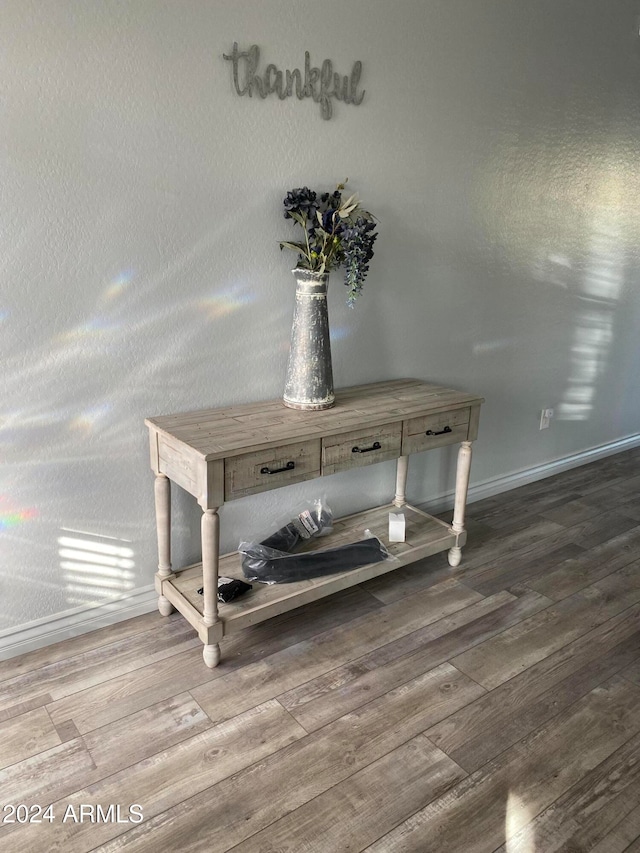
[238, 490, 393, 584]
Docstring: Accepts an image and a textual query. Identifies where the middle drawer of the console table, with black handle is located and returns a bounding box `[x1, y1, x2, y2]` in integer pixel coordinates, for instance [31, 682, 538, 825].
[322, 422, 402, 474]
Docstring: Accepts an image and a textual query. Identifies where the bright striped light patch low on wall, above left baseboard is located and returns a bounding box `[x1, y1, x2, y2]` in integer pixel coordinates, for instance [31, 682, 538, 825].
[58, 528, 135, 607]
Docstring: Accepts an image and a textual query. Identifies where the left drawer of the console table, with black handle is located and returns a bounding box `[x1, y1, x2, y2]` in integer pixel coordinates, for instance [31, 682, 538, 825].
[224, 439, 320, 501]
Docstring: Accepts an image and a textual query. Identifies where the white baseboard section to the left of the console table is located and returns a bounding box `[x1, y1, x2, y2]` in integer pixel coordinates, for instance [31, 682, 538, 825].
[0, 584, 158, 660]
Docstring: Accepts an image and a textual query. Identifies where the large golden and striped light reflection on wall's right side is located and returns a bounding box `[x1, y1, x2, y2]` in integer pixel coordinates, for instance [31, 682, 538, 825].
[474, 137, 640, 430]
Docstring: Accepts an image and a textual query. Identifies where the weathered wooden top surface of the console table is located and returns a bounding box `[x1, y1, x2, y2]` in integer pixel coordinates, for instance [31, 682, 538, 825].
[145, 379, 484, 460]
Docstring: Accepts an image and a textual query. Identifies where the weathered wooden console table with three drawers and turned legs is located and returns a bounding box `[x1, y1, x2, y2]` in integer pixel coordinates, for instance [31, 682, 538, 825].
[145, 379, 484, 667]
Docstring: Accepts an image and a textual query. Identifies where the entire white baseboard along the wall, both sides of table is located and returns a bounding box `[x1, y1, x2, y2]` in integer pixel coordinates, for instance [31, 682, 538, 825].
[0, 434, 640, 660]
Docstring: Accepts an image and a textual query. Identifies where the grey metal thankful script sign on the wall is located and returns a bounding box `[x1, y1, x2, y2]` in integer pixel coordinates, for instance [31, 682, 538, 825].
[222, 42, 365, 119]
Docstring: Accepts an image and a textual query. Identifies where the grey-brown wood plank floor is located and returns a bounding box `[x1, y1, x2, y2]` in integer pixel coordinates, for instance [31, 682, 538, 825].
[0, 450, 640, 853]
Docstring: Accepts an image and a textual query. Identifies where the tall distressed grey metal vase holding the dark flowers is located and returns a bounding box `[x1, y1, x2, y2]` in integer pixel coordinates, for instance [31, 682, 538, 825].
[283, 268, 335, 409]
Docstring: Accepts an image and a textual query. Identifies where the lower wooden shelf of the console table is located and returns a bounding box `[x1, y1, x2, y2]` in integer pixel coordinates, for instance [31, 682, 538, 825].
[162, 504, 466, 634]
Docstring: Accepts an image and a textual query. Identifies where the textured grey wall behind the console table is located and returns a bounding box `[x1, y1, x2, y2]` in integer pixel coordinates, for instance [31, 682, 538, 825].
[0, 0, 640, 630]
